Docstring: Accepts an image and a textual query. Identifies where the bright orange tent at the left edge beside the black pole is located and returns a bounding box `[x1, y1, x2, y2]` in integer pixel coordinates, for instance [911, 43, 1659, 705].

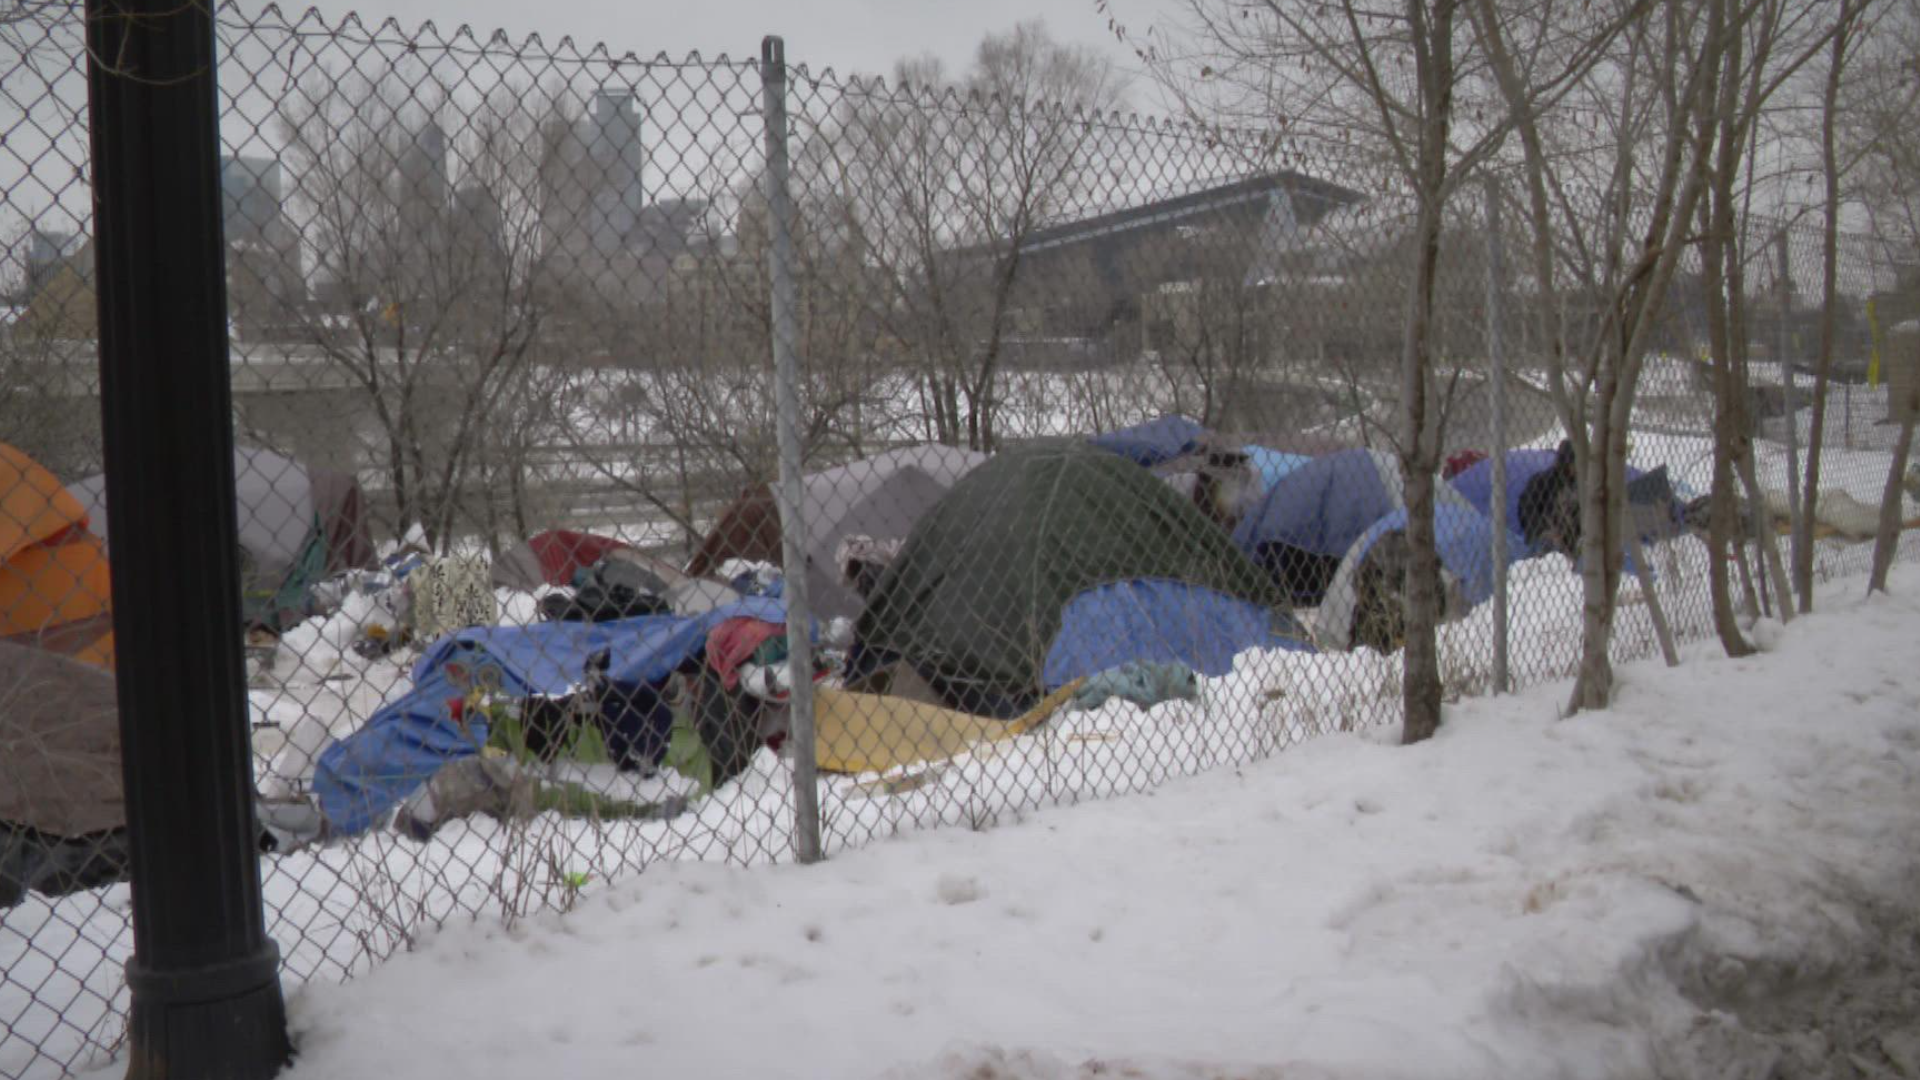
[0, 442, 113, 667]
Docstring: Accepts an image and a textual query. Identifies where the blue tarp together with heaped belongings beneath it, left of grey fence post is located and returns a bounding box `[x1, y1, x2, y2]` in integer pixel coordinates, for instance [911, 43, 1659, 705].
[313, 596, 824, 834]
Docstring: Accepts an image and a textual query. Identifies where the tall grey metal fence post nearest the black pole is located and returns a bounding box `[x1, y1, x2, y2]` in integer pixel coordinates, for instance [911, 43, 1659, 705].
[760, 35, 820, 863]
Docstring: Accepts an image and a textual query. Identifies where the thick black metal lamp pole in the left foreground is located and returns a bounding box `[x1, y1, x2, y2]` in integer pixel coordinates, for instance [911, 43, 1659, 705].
[86, 0, 288, 1080]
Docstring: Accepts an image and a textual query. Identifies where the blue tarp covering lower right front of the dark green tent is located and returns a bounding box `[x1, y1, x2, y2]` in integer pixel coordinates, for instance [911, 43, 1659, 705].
[1041, 578, 1311, 690]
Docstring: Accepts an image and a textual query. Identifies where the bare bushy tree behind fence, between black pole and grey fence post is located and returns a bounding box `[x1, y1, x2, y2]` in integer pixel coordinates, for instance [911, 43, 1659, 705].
[280, 71, 549, 546]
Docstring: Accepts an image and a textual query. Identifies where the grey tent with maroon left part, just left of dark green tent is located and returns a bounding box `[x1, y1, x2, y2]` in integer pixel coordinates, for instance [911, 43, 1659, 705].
[685, 446, 987, 619]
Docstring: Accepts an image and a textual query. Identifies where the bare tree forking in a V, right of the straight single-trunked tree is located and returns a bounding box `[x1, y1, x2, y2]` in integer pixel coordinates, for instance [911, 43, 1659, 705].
[1475, 0, 1728, 709]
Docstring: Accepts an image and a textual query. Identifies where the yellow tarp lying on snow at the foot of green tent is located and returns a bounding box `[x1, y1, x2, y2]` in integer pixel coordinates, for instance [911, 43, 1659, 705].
[814, 678, 1081, 773]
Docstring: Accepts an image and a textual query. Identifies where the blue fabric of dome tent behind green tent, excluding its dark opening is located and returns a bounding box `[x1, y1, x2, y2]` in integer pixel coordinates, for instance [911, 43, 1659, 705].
[1233, 450, 1400, 557]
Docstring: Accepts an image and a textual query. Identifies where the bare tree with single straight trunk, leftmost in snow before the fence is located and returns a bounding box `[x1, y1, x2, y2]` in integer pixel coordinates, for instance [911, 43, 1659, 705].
[1158, 0, 1630, 742]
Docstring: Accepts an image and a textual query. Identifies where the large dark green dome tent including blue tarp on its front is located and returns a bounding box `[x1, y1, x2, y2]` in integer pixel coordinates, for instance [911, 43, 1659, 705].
[851, 442, 1298, 717]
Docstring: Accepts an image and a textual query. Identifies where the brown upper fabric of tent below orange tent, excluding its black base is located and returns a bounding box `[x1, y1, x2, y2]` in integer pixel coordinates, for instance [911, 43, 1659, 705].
[0, 642, 127, 836]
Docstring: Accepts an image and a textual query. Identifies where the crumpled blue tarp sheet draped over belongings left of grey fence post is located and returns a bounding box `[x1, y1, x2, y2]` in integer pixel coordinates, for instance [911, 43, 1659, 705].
[313, 596, 787, 834]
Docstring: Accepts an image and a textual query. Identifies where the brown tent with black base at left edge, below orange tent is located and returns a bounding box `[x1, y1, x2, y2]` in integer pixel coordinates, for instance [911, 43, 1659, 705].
[0, 642, 127, 907]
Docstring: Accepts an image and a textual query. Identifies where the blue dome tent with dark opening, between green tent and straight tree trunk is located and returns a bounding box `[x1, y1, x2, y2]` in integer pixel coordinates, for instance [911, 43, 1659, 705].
[1233, 441, 1473, 607]
